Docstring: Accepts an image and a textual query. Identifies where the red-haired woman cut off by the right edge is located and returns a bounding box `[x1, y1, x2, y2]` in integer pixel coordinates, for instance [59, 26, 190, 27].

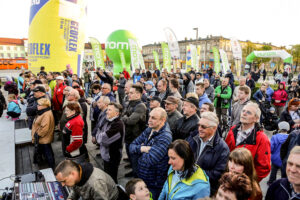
[279, 98, 300, 132]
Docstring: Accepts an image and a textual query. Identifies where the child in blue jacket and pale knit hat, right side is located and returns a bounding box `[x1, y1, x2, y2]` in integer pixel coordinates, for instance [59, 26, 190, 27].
[268, 121, 290, 185]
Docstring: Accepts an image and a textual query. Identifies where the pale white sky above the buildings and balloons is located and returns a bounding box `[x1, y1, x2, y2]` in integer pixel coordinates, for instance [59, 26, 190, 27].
[0, 0, 300, 48]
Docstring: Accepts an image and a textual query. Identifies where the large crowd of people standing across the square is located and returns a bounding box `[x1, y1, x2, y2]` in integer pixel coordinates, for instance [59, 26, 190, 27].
[0, 66, 300, 200]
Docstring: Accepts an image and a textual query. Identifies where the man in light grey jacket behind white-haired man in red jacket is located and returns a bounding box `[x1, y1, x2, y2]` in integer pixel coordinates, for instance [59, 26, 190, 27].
[231, 85, 250, 126]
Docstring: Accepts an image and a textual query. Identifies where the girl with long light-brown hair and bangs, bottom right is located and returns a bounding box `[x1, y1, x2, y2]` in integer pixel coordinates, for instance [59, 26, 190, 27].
[227, 148, 262, 200]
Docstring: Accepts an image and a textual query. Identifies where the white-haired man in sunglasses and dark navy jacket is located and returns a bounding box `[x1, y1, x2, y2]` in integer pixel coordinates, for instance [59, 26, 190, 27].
[187, 112, 229, 194]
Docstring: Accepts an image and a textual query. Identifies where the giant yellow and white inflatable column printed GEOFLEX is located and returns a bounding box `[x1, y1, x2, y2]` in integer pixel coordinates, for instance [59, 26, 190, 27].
[28, 0, 86, 76]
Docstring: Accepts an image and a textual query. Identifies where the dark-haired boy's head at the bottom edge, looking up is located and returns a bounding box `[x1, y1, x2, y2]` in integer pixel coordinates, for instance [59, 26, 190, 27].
[125, 178, 152, 200]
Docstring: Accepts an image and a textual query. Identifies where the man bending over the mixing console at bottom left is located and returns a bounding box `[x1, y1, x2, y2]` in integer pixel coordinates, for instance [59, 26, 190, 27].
[54, 160, 119, 200]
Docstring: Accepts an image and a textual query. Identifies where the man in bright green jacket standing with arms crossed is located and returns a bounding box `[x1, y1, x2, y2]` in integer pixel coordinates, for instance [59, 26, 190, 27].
[214, 78, 232, 129]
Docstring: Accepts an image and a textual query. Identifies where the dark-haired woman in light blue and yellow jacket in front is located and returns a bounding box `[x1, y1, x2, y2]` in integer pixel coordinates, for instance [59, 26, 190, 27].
[159, 140, 210, 200]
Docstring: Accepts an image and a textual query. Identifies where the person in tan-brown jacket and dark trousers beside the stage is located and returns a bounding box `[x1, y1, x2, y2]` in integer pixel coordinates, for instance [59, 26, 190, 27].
[31, 98, 55, 169]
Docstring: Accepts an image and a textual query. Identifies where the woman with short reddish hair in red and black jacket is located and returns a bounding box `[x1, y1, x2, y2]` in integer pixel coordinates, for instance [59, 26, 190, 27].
[62, 102, 87, 163]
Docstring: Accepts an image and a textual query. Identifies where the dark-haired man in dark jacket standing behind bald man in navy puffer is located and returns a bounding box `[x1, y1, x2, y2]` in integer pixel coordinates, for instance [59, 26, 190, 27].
[122, 84, 147, 177]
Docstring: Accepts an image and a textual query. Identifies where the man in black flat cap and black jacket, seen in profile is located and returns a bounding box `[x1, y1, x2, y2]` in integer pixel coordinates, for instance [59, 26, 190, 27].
[172, 97, 199, 140]
